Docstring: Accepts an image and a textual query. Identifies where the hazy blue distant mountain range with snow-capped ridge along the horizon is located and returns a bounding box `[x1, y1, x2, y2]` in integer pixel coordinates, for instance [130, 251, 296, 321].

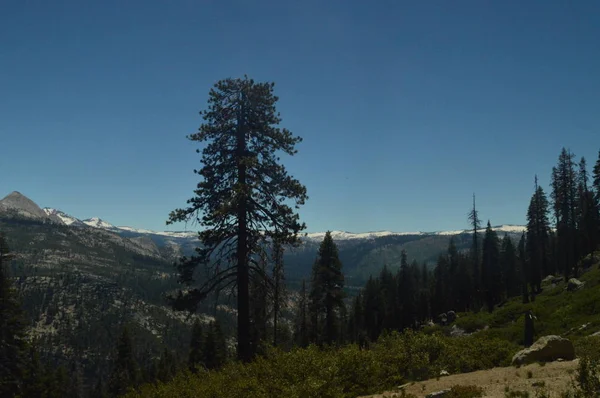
[0, 192, 525, 285]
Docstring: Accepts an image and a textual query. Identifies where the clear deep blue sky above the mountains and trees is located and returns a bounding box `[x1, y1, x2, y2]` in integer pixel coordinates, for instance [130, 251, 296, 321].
[0, 0, 600, 232]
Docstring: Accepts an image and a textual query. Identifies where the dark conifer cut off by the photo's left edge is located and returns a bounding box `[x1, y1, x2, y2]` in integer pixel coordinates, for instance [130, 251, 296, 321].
[0, 233, 27, 397]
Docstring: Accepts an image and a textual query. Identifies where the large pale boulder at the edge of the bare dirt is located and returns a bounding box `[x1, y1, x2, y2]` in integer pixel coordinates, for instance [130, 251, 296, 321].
[512, 335, 575, 365]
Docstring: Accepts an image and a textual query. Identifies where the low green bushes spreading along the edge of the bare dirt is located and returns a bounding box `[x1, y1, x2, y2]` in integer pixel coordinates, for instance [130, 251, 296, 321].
[124, 331, 518, 398]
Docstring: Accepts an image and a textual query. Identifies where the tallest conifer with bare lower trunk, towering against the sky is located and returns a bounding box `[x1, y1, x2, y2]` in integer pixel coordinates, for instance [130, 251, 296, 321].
[168, 77, 307, 361]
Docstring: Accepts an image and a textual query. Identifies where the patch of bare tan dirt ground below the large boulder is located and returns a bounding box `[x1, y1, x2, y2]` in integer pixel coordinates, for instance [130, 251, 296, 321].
[363, 360, 578, 398]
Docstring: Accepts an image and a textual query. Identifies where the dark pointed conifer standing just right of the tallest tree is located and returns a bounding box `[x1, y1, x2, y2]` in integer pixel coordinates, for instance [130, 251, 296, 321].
[310, 231, 344, 344]
